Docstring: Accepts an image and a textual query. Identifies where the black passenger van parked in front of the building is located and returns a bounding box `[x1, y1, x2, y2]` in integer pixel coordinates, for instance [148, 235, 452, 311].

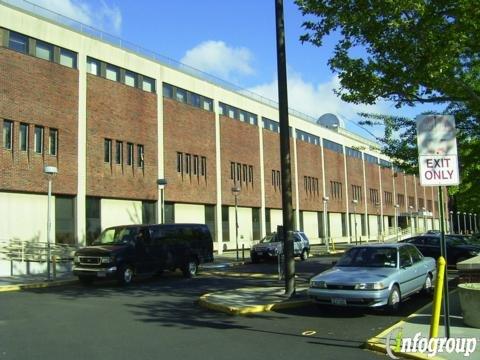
[73, 224, 213, 284]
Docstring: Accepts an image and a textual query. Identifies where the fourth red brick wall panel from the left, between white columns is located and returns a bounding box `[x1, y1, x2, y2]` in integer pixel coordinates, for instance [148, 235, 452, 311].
[220, 116, 261, 207]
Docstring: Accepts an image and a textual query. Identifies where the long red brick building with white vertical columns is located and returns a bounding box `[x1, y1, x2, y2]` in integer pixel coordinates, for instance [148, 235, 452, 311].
[0, 0, 446, 251]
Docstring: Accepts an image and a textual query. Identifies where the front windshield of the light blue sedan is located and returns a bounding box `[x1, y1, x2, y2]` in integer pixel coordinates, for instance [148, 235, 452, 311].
[337, 247, 397, 268]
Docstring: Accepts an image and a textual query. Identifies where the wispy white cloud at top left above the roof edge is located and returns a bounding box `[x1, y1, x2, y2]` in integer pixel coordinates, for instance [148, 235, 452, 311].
[31, 0, 122, 35]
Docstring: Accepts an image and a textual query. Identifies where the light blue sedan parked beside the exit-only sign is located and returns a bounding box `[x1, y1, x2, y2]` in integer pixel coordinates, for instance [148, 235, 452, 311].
[308, 243, 436, 312]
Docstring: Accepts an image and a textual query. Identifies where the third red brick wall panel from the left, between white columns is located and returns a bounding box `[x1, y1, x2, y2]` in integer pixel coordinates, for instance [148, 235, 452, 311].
[163, 98, 217, 204]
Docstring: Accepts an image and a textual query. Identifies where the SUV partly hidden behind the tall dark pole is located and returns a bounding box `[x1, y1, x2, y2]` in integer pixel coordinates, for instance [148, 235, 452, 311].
[250, 231, 310, 263]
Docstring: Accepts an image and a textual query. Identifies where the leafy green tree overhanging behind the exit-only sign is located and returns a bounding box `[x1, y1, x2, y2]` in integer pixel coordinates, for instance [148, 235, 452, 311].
[295, 0, 480, 217]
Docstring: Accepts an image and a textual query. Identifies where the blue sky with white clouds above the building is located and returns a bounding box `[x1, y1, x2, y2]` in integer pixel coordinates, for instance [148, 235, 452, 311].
[30, 0, 438, 137]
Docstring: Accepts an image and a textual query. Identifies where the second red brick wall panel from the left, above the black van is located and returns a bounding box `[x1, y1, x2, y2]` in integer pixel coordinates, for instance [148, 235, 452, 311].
[87, 74, 158, 200]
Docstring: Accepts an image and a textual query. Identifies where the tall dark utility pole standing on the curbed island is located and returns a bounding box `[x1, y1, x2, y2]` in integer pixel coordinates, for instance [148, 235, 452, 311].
[275, 0, 295, 296]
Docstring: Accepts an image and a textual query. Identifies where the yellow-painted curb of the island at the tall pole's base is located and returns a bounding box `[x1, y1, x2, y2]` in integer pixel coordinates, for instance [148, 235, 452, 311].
[198, 293, 312, 315]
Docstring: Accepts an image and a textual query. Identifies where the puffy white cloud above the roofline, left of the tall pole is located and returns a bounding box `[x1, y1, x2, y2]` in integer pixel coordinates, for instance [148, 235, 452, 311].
[180, 40, 254, 82]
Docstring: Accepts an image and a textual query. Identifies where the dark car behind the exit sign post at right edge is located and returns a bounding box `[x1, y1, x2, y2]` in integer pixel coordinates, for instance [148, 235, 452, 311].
[401, 235, 480, 266]
